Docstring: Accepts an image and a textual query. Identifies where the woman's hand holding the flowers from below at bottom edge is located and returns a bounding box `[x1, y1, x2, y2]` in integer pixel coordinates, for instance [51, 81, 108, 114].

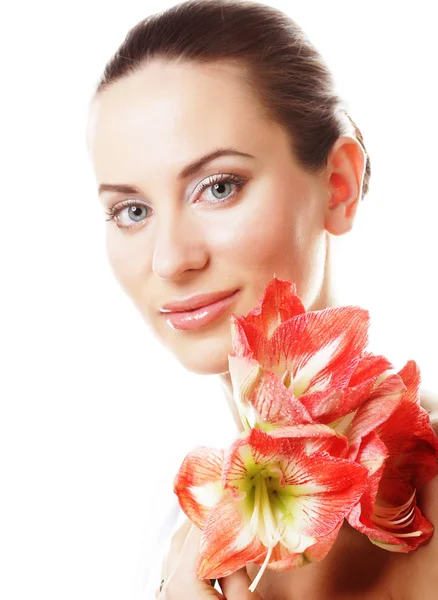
[156, 519, 262, 600]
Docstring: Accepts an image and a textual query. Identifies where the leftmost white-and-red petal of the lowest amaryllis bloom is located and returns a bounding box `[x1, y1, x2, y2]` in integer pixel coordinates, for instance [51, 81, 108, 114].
[174, 446, 224, 529]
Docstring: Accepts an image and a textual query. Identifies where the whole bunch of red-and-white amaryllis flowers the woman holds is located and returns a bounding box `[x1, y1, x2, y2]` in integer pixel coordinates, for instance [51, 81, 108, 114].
[174, 277, 438, 591]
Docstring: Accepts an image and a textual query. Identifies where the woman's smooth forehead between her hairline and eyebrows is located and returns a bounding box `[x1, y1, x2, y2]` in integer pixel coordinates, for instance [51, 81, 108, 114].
[87, 61, 272, 181]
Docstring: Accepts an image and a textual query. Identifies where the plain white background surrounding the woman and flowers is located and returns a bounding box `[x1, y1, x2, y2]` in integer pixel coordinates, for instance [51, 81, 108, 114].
[0, 0, 438, 600]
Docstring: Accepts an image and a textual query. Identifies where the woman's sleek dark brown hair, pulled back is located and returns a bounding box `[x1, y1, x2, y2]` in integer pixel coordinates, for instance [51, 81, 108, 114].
[96, 0, 371, 198]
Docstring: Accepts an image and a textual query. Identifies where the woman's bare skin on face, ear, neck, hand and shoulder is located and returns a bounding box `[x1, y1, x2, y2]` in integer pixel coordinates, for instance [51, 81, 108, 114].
[87, 61, 438, 600]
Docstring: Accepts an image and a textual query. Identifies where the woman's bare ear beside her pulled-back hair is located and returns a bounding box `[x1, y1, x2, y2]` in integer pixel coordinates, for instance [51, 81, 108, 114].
[325, 135, 366, 235]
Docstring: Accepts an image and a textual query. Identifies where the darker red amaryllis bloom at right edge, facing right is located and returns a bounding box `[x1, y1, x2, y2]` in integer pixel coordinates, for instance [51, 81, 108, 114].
[348, 361, 438, 552]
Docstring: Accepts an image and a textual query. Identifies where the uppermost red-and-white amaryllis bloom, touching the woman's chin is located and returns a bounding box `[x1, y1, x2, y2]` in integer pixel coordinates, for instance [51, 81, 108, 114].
[228, 277, 392, 431]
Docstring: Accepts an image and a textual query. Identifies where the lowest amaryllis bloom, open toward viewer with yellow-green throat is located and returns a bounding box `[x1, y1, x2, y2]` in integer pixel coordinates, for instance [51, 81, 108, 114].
[174, 424, 367, 590]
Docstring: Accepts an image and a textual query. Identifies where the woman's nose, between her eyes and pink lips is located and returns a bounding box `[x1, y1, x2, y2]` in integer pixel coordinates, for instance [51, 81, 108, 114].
[152, 211, 208, 280]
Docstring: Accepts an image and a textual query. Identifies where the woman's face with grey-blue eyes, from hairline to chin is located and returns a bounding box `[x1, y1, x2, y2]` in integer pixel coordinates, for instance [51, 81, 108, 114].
[88, 61, 327, 374]
